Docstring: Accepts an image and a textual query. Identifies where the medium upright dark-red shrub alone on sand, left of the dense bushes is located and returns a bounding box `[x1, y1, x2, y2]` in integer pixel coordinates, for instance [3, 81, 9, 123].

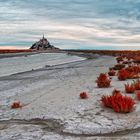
[96, 73, 111, 88]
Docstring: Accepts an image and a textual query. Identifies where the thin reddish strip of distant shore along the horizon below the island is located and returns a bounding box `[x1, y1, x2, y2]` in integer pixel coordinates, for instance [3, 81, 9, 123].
[0, 49, 140, 59]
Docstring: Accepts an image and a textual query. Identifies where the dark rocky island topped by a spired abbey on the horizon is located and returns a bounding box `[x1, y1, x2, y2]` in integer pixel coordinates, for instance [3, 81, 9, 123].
[30, 35, 59, 50]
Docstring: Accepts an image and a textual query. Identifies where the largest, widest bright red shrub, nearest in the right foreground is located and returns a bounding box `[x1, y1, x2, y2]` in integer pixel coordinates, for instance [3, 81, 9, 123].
[101, 93, 134, 113]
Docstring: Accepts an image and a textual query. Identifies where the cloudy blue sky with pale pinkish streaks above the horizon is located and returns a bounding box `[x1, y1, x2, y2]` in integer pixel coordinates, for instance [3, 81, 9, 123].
[0, 0, 140, 50]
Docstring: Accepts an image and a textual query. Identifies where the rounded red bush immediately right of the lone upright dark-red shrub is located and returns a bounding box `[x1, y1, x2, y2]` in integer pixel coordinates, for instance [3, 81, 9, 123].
[118, 69, 129, 81]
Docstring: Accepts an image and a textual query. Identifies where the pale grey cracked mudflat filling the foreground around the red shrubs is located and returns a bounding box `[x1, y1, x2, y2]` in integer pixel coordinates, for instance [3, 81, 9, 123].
[0, 56, 140, 139]
